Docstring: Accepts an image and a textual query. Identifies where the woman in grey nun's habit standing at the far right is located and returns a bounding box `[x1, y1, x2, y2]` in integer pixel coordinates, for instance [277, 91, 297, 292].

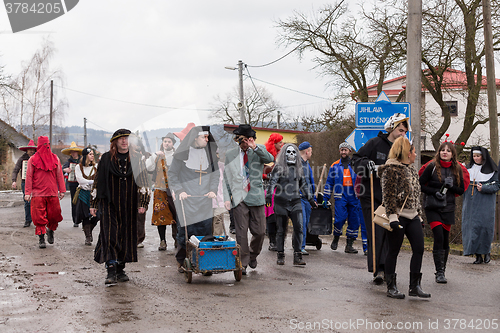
[462, 147, 500, 264]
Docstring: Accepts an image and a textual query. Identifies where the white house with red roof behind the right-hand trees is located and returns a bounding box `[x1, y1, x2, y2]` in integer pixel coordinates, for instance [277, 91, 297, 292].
[362, 69, 500, 152]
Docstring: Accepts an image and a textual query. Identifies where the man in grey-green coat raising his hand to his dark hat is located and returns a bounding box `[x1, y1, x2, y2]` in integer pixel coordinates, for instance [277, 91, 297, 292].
[224, 124, 274, 275]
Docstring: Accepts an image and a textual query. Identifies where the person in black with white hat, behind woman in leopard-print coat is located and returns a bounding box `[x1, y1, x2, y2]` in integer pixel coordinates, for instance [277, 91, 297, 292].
[351, 113, 411, 284]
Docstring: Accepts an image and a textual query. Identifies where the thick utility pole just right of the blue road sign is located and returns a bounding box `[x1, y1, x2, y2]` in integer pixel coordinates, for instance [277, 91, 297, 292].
[406, 0, 422, 170]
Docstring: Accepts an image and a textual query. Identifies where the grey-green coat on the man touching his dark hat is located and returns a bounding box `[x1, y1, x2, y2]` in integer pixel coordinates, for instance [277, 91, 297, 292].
[224, 144, 274, 207]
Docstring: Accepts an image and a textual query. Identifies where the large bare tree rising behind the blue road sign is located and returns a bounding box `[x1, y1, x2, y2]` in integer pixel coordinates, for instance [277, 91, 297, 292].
[277, 0, 406, 102]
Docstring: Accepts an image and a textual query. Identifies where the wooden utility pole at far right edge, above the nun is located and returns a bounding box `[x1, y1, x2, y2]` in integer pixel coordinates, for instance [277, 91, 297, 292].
[483, 0, 499, 163]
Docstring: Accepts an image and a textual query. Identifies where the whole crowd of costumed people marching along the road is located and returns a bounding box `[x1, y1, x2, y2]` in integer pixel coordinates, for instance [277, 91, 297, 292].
[12, 114, 500, 298]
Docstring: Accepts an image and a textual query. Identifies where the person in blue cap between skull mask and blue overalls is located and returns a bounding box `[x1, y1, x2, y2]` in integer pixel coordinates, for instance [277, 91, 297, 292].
[299, 141, 316, 256]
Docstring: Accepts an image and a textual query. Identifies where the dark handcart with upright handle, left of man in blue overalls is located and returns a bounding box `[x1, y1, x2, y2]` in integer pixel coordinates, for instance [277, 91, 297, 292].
[306, 164, 333, 250]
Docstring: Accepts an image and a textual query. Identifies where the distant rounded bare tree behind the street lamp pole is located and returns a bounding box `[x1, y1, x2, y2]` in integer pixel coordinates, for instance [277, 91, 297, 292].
[210, 86, 281, 127]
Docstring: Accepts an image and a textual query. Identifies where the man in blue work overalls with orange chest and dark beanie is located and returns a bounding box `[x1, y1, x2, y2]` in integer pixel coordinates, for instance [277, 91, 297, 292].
[323, 142, 363, 253]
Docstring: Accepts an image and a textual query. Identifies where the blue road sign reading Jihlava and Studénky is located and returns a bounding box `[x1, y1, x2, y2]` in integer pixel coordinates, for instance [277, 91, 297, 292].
[356, 92, 411, 129]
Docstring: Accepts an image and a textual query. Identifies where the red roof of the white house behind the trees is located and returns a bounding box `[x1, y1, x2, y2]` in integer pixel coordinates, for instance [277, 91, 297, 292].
[367, 68, 500, 97]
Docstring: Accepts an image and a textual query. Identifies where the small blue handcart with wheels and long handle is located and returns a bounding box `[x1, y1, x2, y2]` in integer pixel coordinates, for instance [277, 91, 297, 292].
[181, 200, 243, 283]
